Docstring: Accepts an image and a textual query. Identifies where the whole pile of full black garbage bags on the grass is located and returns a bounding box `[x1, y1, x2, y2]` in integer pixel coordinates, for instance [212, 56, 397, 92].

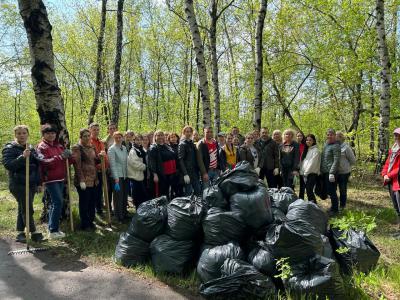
[114, 162, 380, 299]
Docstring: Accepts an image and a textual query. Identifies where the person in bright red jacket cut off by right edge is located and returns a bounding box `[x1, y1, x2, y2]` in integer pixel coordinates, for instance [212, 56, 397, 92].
[382, 128, 400, 237]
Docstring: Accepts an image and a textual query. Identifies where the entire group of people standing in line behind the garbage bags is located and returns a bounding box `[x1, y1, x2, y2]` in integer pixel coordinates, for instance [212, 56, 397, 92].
[2, 123, 400, 242]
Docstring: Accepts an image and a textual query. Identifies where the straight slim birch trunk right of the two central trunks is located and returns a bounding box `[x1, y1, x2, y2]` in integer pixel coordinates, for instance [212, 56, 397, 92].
[253, 0, 268, 130]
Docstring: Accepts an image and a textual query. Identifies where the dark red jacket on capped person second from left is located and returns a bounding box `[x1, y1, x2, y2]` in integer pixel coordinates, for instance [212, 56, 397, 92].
[37, 140, 66, 183]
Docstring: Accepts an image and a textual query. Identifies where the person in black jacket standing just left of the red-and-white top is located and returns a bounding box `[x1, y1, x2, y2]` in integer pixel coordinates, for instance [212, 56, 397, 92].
[178, 126, 201, 196]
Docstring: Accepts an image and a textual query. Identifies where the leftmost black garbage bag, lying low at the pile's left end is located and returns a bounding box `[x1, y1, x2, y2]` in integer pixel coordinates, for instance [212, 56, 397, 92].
[114, 232, 150, 267]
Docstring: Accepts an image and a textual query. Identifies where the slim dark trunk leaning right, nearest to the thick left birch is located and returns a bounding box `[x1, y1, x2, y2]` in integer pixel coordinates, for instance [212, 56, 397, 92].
[88, 0, 107, 125]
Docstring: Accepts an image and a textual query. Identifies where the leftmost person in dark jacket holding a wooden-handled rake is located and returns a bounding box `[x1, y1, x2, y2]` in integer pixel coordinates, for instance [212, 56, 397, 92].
[2, 125, 43, 242]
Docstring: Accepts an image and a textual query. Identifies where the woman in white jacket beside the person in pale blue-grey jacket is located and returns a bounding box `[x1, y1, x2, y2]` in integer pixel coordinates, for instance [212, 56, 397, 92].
[128, 135, 148, 209]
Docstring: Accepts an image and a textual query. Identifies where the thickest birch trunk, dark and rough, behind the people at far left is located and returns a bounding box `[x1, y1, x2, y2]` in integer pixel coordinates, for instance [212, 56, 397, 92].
[18, 0, 69, 145]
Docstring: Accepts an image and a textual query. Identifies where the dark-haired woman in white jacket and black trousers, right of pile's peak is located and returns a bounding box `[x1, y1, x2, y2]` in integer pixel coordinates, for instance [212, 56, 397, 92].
[300, 134, 321, 203]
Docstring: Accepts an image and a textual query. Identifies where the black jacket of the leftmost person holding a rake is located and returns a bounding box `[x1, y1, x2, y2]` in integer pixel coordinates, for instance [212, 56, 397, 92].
[2, 142, 40, 186]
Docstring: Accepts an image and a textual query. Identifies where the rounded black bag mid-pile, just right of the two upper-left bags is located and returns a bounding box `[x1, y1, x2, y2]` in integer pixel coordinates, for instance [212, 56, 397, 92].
[203, 207, 246, 245]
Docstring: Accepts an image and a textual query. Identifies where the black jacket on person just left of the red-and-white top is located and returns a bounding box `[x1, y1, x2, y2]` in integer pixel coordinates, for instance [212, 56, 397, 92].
[178, 139, 199, 177]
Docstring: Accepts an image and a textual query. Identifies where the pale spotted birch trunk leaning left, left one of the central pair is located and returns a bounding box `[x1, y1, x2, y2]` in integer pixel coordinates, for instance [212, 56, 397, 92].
[185, 0, 211, 127]
